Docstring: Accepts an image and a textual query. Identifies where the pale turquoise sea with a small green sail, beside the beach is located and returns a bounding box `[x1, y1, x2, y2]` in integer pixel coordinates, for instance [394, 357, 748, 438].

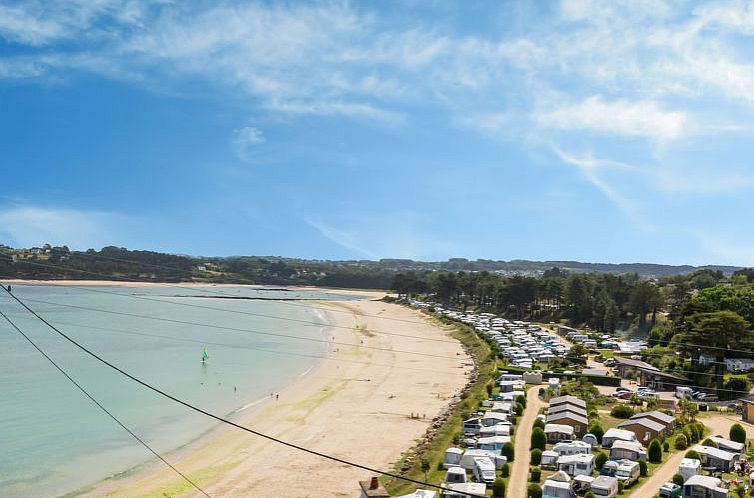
[0, 284, 353, 498]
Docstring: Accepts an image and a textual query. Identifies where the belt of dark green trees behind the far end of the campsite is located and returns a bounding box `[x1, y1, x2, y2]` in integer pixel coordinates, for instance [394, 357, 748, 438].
[392, 268, 749, 332]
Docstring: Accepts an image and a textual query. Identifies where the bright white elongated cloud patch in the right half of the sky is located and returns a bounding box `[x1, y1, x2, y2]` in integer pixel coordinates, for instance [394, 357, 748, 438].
[535, 96, 689, 143]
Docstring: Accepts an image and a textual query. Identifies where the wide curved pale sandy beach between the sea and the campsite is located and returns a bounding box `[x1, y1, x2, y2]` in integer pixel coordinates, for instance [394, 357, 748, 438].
[85, 291, 470, 498]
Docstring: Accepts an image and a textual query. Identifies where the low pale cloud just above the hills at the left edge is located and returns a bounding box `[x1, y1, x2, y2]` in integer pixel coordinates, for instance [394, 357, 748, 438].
[0, 206, 128, 249]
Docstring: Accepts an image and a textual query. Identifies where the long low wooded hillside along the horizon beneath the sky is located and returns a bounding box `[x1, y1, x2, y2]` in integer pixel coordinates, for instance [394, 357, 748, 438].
[0, 245, 740, 289]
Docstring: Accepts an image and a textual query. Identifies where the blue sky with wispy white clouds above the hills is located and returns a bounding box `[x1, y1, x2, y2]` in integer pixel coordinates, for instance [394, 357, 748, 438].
[0, 0, 754, 265]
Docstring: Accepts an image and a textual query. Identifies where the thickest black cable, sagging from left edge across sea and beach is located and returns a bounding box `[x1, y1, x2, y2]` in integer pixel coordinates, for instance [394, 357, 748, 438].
[0, 285, 487, 498]
